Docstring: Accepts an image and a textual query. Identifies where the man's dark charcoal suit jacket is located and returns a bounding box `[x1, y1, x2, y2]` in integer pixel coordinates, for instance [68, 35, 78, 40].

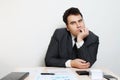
[45, 28, 99, 67]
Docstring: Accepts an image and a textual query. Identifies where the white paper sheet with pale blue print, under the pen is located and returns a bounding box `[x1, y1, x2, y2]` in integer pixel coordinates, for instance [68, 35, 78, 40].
[35, 69, 78, 80]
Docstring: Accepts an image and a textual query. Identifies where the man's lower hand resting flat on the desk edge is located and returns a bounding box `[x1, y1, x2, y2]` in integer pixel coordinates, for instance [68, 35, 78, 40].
[71, 59, 90, 69]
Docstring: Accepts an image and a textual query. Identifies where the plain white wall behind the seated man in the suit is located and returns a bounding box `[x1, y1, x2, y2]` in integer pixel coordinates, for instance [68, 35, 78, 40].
[0, 0, 120, 77]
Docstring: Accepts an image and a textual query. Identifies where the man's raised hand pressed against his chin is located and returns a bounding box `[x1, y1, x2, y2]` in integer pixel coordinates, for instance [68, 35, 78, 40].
[77, 28, 89, 42]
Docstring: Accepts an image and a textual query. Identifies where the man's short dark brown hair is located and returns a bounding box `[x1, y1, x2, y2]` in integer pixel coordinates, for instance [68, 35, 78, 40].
[63, 7, 83, 25]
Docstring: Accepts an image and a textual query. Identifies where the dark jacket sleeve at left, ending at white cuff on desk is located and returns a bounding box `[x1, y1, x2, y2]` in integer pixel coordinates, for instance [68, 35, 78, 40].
[45, 30, 67, 67]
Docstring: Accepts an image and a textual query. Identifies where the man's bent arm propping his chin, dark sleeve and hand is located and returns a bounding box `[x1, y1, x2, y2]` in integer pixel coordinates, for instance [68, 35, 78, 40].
[77, 28, 99, 67]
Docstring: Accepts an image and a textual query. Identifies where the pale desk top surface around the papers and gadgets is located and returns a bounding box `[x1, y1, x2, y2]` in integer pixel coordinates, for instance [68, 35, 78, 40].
[15, 67, 120, 80]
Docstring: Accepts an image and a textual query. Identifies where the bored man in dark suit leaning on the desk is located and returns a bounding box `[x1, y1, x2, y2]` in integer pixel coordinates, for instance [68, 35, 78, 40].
[45, 7, 99, 69]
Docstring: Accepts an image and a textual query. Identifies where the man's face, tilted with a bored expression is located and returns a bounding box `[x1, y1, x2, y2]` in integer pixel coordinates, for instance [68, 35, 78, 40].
[67, 14, 85, 36]
